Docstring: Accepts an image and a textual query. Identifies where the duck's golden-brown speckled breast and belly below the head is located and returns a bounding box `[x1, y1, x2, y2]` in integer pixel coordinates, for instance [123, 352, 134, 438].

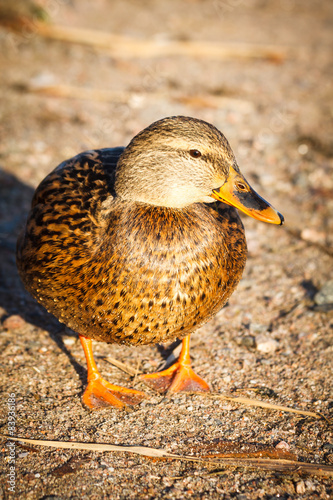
[63, 202, 246, 344]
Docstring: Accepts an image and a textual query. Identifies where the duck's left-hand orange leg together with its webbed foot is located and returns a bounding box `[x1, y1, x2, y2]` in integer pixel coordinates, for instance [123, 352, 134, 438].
[79, 335, 145, 410]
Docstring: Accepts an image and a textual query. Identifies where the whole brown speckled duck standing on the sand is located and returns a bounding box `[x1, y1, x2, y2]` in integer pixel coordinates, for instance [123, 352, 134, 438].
[17, 116, 284, 409]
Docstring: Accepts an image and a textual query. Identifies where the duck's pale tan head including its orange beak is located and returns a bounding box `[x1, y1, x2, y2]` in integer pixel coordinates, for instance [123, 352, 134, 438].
[115, 116, 284, 224]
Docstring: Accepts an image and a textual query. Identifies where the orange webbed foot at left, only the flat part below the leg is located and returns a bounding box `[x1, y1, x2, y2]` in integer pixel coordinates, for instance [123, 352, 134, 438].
[82, 376, 146, 410]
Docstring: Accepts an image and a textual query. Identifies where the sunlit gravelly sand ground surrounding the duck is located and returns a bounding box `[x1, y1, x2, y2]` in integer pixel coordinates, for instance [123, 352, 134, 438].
[0, 0, 333, 500]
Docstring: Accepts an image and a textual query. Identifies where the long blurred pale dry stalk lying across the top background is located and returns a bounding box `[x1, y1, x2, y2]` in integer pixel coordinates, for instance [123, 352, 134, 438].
[0, 9, 286, 63]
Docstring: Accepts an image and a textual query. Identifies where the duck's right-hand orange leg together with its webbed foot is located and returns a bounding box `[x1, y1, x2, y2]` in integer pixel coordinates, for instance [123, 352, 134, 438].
[140, 335, 210, 394]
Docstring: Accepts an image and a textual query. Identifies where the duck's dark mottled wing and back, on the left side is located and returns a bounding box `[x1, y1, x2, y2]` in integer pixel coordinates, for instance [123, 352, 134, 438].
[17, 148, 123, 281]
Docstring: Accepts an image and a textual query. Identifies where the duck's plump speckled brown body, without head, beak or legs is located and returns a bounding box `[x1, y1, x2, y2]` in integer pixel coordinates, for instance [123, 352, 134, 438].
[17, 148, 246, 344]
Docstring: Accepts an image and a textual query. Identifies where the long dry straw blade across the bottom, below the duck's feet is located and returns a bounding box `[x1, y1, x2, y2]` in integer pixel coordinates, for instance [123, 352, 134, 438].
[4, 435, 333, 479]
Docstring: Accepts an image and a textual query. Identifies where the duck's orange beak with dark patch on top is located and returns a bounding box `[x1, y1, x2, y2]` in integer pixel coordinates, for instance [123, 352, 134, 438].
[211, 167, 284, 224]
